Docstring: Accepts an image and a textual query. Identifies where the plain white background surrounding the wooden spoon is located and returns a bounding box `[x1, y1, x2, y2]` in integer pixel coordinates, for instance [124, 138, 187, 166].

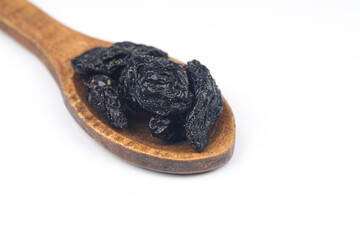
[0, 0, 360, 240]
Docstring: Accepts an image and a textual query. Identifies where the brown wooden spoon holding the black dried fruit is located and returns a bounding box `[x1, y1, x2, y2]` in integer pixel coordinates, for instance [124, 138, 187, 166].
[0, 0, 235, 174]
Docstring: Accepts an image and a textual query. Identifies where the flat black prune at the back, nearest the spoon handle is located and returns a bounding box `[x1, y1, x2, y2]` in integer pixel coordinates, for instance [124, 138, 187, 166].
[71, 42, 167, 79]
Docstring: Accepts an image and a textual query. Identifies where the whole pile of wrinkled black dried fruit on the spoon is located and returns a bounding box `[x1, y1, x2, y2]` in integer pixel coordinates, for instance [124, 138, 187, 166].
[71, 42, 223, 152]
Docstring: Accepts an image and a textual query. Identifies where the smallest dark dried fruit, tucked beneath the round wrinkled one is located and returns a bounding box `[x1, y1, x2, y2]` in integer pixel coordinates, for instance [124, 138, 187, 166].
[149, 115, 185, 142]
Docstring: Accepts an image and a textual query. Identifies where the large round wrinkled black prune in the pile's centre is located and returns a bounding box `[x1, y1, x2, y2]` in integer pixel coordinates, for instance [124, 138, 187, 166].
[120, 56, 193, 116]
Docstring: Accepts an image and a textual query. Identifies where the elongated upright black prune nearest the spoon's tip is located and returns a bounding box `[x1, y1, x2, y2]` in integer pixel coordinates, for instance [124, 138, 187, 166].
[185, 60, 223, 152]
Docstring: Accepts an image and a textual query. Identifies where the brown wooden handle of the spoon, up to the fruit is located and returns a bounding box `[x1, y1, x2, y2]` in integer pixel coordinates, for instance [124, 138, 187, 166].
[0, 0, 107, 85]
